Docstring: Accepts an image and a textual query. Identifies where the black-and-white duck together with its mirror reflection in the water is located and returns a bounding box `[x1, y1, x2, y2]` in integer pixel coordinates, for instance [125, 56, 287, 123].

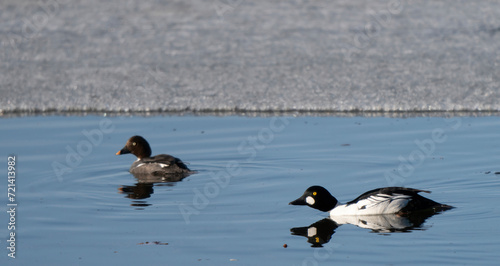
[290, 186, 453, 247]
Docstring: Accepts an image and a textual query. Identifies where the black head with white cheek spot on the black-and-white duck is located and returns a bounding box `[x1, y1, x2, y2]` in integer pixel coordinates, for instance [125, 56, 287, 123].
[289, 186, 338, 212]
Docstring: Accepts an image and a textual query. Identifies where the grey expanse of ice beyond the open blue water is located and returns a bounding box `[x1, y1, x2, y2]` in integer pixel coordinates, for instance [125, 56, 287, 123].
[0, 0, 500, 113]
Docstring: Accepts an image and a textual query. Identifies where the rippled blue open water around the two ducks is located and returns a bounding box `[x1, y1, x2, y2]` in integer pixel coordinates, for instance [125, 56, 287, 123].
[0, 115, 500, 265]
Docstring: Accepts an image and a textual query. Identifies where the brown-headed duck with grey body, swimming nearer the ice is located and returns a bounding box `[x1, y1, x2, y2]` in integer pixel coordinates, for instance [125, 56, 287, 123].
[116, 136, 194, 178]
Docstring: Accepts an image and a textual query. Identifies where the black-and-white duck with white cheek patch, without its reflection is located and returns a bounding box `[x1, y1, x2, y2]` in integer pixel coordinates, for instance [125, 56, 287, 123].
[290, 186, 453, 217]
